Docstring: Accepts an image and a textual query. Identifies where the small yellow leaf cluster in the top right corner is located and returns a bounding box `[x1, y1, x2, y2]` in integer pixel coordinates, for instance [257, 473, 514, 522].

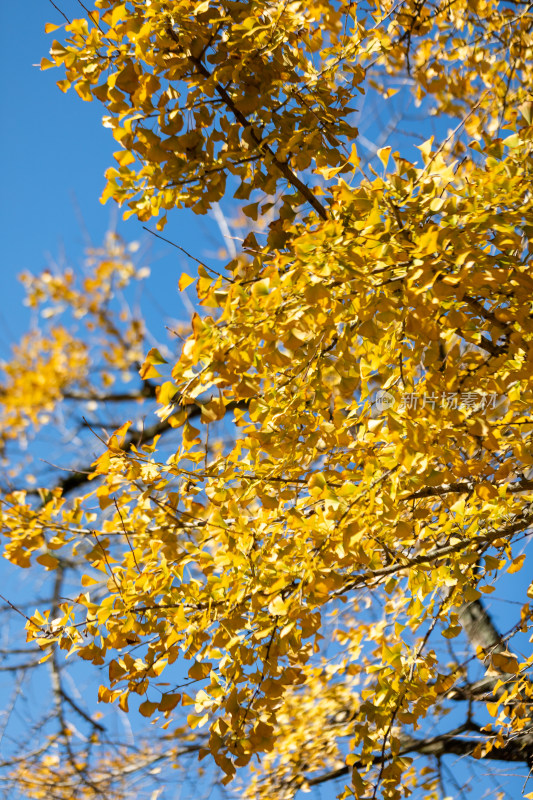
[376, 0, 533, 135]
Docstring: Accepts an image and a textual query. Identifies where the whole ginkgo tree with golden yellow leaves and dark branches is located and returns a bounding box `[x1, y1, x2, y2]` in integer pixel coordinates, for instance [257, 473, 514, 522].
[0, 0, 533, 800]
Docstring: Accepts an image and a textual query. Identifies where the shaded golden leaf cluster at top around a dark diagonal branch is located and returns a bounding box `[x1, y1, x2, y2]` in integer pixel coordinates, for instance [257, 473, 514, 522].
[42, 0, 364, 220]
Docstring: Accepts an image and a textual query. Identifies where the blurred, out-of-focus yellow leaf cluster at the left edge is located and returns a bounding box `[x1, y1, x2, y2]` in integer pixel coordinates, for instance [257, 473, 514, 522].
[0, 234, 148, 460]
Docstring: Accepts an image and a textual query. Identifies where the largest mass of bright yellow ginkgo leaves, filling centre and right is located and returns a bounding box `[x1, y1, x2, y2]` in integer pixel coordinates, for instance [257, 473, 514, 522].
[12, 122, 533, 784]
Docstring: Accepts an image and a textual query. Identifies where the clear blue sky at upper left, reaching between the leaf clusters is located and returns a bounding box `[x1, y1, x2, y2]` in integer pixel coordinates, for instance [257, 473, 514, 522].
[0, 0, 223, 358]
